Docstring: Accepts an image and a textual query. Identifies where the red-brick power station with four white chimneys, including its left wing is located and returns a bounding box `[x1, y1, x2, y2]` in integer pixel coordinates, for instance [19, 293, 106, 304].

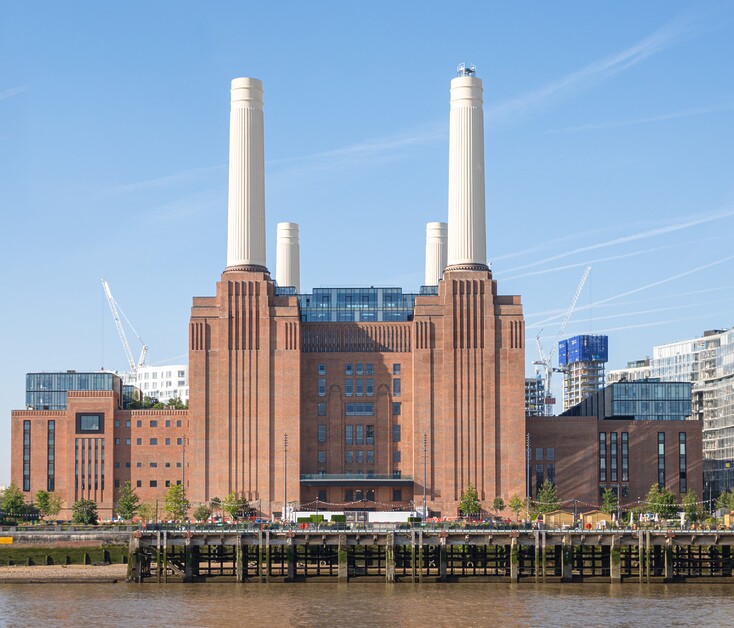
[12, 66, 526, 518]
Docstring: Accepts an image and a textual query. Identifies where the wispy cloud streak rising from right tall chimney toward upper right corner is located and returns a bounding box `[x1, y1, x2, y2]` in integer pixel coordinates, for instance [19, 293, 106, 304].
[490, 19, 691, 119]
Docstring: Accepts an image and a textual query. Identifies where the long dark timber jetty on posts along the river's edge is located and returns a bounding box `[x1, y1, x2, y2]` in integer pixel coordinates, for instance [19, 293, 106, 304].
[128, 526, 734, 584]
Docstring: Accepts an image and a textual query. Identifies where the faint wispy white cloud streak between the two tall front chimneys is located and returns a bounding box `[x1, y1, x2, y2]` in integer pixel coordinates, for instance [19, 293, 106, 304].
[266, 122, 448, 177]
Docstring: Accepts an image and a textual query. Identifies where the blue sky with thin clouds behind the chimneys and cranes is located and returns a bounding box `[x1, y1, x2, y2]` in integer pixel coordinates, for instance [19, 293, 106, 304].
[0, 0, 734, 484]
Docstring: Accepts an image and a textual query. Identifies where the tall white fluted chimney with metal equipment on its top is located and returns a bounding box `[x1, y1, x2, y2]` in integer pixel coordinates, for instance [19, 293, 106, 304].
[448, 65, 487, 270]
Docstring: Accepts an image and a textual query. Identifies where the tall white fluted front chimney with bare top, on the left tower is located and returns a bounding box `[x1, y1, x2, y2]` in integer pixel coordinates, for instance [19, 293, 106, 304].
[227, 78, 267, 272]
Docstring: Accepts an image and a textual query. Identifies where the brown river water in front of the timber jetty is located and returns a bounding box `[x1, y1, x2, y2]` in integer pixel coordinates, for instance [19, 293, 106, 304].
[0, 583, 734, 628]
